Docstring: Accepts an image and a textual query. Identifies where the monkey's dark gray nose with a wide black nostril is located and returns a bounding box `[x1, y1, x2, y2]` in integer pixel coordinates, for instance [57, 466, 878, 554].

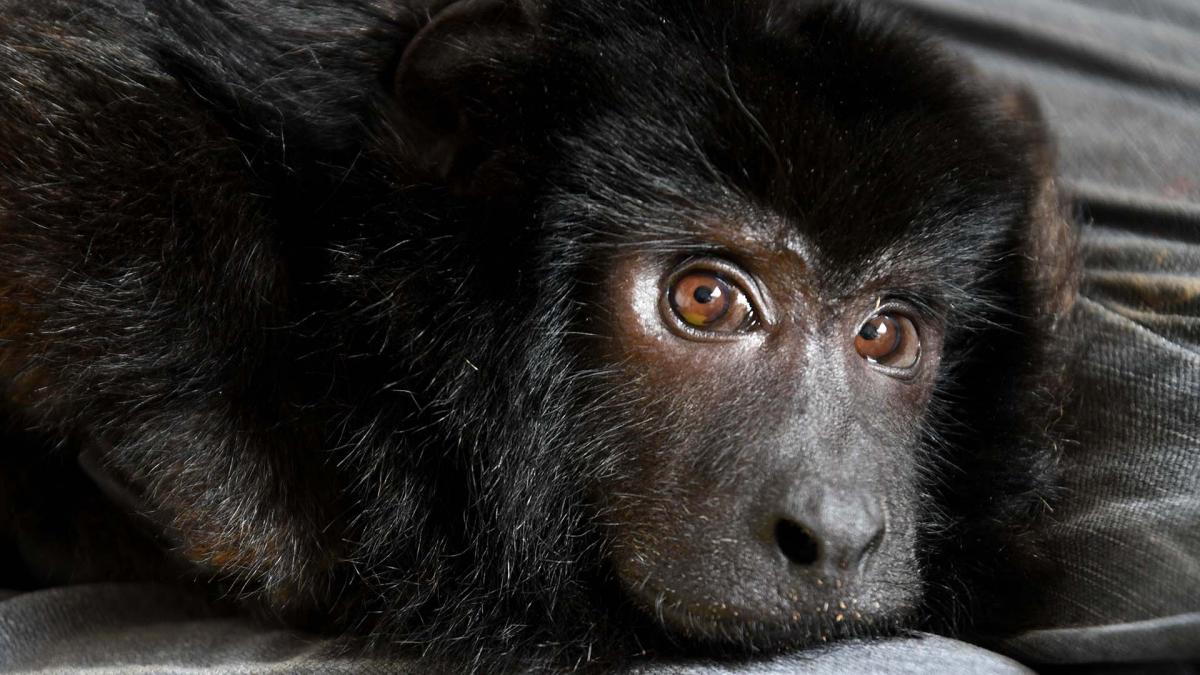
[770, 484, 886, 577]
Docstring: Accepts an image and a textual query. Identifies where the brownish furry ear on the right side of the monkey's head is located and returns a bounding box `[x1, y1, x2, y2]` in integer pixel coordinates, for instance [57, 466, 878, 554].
[997, 85, 1080, 329]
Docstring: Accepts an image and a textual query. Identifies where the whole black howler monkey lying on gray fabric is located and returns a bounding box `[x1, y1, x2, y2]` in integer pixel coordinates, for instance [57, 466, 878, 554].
[0, 0, 1074, 664]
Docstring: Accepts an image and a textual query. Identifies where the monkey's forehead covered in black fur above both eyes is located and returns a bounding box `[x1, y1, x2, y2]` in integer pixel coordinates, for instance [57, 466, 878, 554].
[506, 0, 1036, 299]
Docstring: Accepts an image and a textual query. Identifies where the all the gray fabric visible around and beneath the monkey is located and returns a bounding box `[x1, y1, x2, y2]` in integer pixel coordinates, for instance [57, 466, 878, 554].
[0, 0, 1200, 673]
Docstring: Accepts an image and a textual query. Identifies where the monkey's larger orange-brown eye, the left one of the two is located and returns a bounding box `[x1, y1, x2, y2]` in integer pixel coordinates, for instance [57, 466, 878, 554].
[667, 269, 752, 334]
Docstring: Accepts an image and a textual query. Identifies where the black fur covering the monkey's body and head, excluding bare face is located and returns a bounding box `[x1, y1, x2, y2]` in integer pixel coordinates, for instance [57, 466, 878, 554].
[0, 0, 1073, 664]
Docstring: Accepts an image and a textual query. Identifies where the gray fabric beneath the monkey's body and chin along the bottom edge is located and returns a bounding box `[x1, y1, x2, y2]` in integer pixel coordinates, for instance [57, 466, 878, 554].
[0, 584, 1030, 675]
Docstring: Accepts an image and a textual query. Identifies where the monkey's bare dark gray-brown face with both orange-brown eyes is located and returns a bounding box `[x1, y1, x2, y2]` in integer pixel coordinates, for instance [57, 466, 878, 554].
[595, 236, 943, 641]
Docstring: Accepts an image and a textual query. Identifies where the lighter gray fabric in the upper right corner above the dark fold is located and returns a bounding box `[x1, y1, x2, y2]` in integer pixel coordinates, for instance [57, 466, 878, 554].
[887, 0, 1200, 210]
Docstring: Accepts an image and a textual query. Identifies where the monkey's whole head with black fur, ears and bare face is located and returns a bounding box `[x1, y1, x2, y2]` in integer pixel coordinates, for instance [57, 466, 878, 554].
[376, 2, 1072, 649]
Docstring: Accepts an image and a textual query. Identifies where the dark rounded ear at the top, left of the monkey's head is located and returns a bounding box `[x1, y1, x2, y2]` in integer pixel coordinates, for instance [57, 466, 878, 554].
[394, 0, 535, 180]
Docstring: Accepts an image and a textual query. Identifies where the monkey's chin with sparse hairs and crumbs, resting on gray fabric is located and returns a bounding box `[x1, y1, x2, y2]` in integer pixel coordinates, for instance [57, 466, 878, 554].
[631, 587, 916, 653]
